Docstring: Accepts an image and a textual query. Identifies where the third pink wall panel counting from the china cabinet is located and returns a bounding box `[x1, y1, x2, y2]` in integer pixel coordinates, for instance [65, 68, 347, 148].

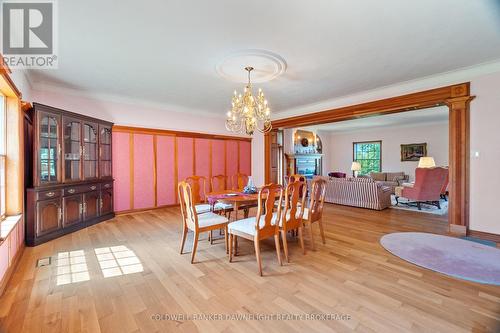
[156, 135, 176, 206]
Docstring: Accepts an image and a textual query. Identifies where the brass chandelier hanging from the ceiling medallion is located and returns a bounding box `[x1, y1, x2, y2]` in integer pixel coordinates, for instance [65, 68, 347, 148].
[226, 67, 272, 135]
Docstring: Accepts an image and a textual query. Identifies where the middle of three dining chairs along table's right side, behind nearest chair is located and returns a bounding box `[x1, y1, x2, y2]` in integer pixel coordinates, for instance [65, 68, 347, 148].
[280, 180, 307, 262]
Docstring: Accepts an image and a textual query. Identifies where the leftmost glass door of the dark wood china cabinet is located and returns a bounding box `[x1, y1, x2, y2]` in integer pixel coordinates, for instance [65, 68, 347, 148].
[38, 112, 60, 184]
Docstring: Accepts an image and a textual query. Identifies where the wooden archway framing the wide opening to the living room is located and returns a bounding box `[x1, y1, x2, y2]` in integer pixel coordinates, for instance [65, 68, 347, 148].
[264, 82, 474, 235]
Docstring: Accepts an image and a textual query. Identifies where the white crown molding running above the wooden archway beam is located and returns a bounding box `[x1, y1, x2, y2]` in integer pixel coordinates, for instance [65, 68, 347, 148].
[272, 59, 500, 120]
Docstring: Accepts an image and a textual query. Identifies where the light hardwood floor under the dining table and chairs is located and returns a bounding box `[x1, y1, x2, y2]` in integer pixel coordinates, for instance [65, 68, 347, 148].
[0, 205, 500, 333]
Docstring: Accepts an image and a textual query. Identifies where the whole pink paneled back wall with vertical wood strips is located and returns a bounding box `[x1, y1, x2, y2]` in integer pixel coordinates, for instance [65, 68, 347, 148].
[112, 129, 251, 212]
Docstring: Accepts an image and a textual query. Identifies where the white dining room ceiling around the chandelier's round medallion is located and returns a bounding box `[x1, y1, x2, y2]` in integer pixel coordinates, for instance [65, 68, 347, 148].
[25, 0, 500, 116]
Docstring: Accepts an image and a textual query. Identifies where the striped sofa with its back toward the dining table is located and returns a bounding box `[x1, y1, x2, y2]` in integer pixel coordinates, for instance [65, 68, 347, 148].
[319, 177, 392, 210]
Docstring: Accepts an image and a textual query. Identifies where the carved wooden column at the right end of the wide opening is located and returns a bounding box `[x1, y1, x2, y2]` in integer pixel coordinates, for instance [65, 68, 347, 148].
[446, 96, 474, 235]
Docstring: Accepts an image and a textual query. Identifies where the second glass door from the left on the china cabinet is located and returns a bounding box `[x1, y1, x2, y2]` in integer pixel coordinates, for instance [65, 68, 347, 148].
[63, 118, 82, 181]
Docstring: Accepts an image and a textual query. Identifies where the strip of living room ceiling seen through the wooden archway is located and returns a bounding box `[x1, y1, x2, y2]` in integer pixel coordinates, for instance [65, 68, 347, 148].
[303, 106, 449, 133]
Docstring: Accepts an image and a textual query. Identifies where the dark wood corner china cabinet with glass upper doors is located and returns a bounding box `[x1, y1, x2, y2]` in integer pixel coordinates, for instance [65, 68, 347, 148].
[25, 103, 114, 246]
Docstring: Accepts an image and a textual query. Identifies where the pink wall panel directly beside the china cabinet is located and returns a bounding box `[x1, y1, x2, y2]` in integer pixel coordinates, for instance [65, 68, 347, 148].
[112, 132, 132, 211]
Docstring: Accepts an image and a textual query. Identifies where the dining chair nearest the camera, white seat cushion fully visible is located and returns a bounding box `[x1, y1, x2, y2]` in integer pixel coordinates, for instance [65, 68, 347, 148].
[228, 184, 283, 276]
